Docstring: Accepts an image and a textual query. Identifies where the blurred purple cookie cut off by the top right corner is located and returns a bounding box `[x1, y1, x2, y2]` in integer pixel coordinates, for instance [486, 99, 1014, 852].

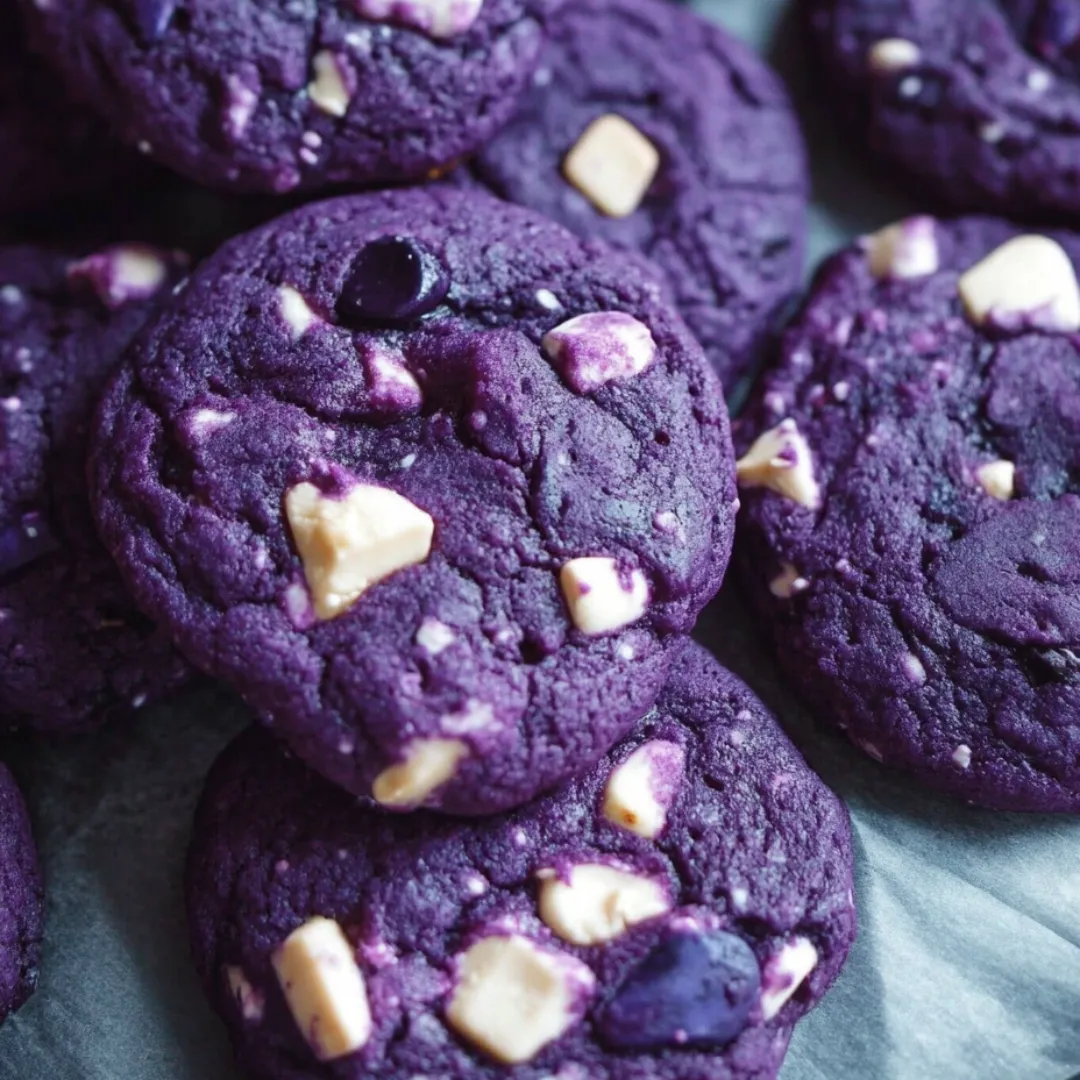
[805, 0, 1080, 220]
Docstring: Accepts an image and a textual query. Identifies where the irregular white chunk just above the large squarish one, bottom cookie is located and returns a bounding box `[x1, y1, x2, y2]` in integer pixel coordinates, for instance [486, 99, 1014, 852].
[539, 863, 672, 945]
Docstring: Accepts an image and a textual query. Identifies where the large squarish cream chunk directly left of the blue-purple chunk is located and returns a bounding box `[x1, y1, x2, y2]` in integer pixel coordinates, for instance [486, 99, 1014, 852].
[446, 934, 595, 1065]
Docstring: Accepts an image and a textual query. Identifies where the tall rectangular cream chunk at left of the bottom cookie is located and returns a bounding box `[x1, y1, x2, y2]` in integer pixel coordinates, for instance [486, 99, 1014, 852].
[271, 917, 372, 1062]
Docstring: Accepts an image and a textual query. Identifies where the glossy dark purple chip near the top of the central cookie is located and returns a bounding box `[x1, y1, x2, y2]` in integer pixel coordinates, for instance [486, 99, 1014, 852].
[337, 237, 450, 324]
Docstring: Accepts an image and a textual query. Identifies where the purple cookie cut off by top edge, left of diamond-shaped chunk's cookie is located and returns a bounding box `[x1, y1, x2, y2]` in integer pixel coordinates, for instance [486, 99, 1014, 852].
[24, 0, 561, 192]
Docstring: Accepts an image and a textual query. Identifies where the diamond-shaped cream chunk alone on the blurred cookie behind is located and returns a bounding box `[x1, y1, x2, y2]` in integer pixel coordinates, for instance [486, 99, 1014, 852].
[563, 112, 660, 217]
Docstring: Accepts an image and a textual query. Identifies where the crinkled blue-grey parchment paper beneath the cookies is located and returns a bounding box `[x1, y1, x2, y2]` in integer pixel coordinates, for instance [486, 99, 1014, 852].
[0, 0, 1080, 1080]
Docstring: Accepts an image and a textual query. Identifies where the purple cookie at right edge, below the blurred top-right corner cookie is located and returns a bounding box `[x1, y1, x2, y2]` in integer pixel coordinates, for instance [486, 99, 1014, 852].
[737, 218, 1080, 813]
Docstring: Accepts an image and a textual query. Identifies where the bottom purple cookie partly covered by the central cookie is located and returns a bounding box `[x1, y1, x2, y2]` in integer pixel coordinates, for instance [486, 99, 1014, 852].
[187, 645, 855, 1080]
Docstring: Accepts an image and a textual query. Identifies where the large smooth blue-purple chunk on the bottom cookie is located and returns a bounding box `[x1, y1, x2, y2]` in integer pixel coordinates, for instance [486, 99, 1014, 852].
[599, 931, 761, 1050]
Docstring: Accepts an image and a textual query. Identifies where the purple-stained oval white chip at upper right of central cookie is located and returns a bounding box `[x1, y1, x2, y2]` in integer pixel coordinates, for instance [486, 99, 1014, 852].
[541, 311, 657, 394]
